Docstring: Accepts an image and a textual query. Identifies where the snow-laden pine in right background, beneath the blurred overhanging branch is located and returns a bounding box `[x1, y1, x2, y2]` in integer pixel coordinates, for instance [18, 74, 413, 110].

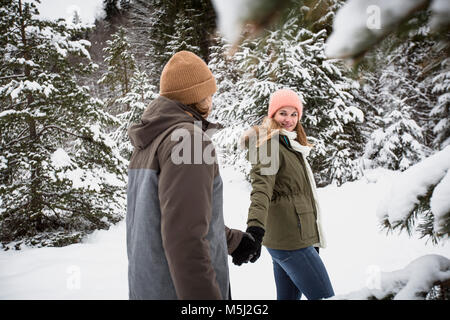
[361, 23, 434, 171]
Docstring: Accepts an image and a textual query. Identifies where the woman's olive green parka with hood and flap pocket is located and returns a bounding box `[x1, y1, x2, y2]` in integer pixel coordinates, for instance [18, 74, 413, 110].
[244, 127, 323, 250]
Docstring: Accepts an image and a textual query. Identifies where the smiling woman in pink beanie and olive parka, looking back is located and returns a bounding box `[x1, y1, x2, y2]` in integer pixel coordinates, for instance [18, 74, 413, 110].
[244, 89, 334, 300]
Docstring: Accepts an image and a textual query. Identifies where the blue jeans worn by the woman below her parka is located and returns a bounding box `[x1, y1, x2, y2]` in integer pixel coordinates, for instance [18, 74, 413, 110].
[267, 246, 334, 300]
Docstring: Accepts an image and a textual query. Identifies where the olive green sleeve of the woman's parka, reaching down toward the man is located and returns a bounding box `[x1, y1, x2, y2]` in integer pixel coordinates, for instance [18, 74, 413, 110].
[247, 141, 280, 229]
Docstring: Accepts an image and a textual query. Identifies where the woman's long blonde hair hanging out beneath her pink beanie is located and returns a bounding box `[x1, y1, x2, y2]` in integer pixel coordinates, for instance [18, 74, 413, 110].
[241, 117, 313, 147]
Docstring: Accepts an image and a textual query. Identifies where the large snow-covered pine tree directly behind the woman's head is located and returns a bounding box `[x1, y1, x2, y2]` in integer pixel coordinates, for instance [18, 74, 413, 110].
[210, 3, 363, 185]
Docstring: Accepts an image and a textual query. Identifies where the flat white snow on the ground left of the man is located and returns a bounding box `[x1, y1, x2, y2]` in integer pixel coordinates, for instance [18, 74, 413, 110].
[0, 223, 128, 299]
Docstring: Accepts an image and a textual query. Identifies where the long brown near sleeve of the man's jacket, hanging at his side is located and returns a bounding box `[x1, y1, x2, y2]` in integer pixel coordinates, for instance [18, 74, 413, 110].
[158, 125, 222, 299]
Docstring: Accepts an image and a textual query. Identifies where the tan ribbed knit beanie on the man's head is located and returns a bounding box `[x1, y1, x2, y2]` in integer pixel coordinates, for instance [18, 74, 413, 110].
[159, 51, 217, 104]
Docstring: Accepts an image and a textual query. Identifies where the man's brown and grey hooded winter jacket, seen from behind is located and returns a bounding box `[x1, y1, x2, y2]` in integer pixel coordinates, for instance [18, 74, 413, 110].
[127, 97, 242, 299]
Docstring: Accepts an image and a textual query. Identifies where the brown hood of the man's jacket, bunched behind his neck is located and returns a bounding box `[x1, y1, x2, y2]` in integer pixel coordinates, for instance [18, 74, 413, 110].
[128, 96, 221, 149]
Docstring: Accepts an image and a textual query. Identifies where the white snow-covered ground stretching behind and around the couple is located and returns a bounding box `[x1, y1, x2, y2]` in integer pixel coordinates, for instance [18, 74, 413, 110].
[0, 168, 450, 299]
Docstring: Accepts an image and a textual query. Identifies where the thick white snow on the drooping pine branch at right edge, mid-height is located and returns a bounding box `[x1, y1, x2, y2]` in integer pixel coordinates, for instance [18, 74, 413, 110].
[377, 146, 450, 231]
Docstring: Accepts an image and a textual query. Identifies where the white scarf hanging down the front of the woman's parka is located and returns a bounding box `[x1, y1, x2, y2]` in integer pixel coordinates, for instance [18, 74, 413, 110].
[280, 129, 326, 248]
